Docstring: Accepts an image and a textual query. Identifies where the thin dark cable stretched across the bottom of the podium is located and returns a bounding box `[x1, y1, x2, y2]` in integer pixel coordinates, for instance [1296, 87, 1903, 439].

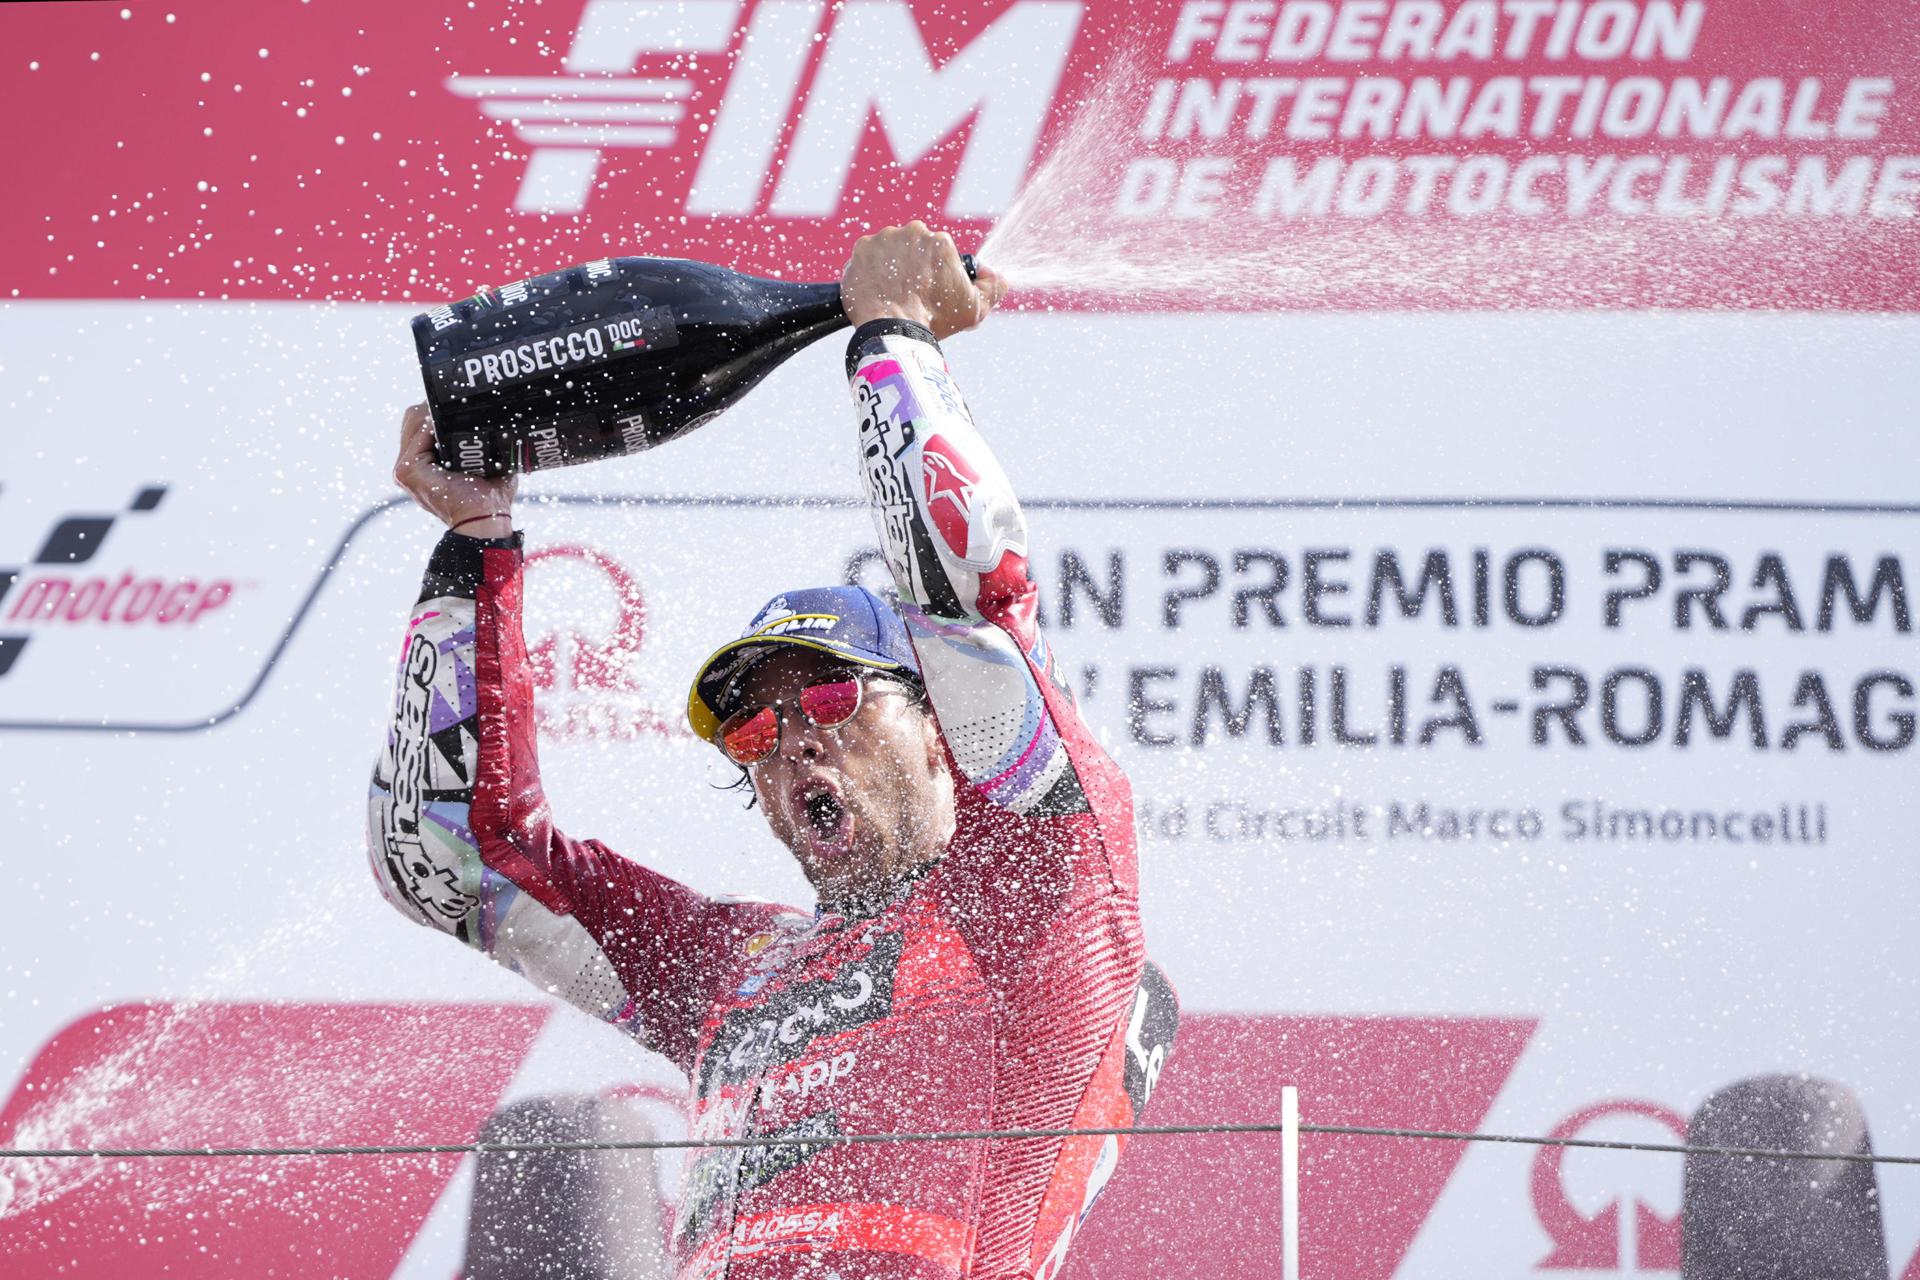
[0, 1125, 1920, 1165]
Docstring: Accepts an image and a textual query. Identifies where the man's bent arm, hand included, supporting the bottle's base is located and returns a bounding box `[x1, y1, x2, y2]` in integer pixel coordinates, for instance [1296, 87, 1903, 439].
[367, 407, 780, 1069]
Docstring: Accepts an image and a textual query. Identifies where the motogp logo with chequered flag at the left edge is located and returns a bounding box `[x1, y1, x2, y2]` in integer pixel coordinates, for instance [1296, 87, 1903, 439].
[0, 484, 234, 677]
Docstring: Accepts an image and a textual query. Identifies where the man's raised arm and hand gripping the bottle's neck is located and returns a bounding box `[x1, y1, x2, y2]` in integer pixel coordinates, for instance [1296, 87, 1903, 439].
[843, 223, 1131, 832]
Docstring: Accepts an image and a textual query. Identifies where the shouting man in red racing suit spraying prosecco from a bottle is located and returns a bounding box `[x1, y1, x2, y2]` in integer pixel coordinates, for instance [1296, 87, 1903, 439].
[369, 223, 1177, 1280]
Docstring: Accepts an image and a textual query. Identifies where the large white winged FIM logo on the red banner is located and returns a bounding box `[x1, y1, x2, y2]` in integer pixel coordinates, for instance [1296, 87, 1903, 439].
[445, 0, 1081, 219]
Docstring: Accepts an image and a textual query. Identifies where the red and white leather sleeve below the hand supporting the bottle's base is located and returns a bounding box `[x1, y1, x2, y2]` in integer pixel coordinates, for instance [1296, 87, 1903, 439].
[374, 533, 791, 1069]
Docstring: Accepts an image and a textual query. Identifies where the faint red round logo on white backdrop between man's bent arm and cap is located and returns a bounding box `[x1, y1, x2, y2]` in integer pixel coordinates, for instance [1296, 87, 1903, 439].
[526, 547, 693, 741]
